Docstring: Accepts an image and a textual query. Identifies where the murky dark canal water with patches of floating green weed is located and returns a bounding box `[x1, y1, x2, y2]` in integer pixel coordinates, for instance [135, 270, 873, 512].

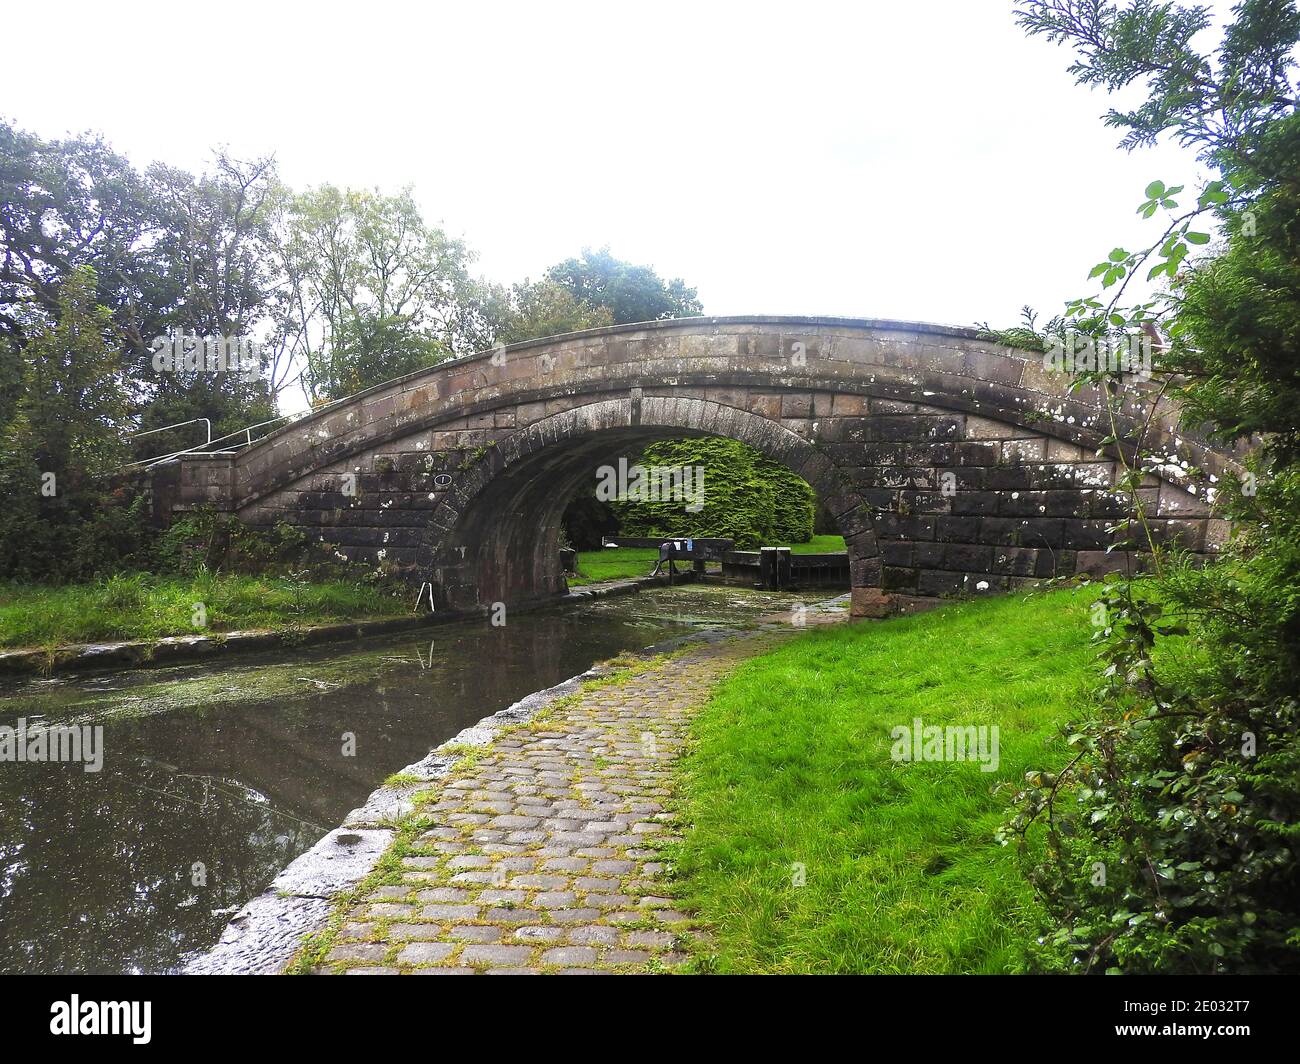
[0, 585, 829, 973]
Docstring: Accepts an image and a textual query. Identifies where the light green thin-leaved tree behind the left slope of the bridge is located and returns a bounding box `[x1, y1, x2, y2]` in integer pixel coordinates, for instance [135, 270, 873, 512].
[278, 185, 491, 403]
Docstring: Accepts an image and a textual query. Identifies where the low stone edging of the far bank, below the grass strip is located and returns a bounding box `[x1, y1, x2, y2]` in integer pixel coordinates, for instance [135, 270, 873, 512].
[0, 572, 696, 676]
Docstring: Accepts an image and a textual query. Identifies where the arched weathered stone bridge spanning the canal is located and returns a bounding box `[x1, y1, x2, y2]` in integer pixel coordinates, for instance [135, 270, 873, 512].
[155, 317, 1231, 614]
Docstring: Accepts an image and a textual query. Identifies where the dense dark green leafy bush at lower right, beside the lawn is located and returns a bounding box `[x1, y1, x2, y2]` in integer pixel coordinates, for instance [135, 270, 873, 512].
[1010, 559, 1300, 973]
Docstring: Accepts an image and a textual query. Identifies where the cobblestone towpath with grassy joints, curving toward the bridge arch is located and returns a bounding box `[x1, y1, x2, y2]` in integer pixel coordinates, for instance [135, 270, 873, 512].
[313, 632, 781, 976]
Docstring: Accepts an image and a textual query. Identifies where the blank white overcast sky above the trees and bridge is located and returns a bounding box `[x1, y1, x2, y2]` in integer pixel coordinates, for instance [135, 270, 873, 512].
[0, 0, 1216, 325]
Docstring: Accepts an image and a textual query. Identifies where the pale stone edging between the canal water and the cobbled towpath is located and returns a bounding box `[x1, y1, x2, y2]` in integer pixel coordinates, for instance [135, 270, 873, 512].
[183, 596, 848, 976]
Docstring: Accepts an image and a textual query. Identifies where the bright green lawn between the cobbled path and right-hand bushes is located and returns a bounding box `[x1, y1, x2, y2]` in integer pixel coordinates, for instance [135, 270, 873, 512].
[676, 588, 1096, 973]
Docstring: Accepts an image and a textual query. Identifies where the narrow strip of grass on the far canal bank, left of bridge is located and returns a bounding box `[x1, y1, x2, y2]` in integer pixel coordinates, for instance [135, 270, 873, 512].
[0, 574, 410, 646]
